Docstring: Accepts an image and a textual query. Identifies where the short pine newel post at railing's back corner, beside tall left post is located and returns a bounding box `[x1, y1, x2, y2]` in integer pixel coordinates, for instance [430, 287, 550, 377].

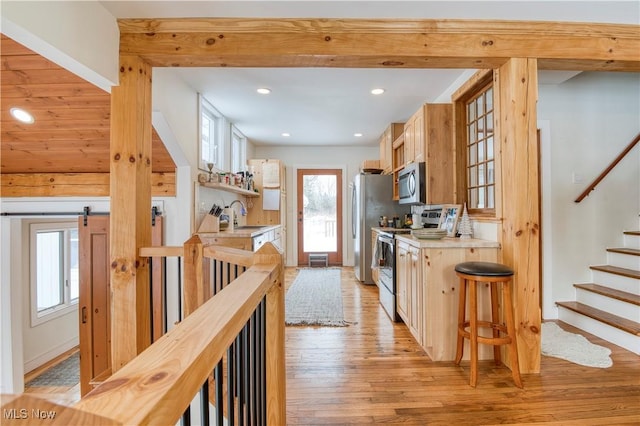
[182, 235, 211, 317]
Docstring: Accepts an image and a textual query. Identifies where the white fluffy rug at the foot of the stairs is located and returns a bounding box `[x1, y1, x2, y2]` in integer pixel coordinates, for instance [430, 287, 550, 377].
[542, 322, 613, 368]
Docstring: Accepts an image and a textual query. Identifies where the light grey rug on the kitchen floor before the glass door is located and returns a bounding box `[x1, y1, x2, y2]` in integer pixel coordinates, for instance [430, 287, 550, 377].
[285, 268, 349, 327]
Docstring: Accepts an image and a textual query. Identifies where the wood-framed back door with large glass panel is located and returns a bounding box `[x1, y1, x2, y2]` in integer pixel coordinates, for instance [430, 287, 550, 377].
[297, 169, 342, 265]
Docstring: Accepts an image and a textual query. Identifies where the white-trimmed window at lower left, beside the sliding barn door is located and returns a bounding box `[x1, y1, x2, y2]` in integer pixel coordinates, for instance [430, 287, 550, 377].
[29, 221, 80, 326]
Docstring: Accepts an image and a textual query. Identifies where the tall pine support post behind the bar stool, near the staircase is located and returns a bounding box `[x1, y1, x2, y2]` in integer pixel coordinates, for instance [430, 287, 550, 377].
[496, 58, 542, 373]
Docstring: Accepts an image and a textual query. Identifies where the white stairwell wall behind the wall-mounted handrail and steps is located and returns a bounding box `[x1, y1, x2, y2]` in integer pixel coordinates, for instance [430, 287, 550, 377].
[538, 73, 640, 319]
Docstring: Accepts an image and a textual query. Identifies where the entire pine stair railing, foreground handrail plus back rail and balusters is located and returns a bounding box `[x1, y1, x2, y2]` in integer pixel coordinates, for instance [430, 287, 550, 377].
[2, 240, 286, 425]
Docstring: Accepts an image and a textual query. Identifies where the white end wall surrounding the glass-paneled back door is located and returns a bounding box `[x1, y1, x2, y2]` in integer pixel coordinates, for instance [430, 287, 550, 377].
[255, 145, 380, 266]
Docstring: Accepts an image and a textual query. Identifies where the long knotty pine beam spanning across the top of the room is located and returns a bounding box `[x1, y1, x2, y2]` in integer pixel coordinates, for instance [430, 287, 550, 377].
[118, 18, 640, 71]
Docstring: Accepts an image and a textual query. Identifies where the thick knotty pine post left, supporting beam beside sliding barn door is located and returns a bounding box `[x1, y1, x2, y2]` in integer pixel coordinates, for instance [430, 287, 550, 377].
[110, 56, 151, 372]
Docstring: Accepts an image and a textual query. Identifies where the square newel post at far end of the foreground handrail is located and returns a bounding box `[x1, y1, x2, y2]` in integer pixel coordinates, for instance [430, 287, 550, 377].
[254, 243, 287, 425]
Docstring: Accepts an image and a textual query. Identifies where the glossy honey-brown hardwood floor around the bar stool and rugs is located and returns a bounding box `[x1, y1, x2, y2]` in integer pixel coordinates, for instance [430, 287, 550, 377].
[285, 268, 640, 425]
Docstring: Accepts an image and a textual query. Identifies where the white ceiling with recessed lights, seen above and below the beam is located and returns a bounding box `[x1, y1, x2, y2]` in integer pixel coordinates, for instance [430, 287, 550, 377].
[100, 0, 640, 146]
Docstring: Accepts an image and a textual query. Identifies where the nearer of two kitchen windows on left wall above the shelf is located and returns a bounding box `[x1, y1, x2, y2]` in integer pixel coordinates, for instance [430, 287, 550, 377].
[198, 95, 224, 170]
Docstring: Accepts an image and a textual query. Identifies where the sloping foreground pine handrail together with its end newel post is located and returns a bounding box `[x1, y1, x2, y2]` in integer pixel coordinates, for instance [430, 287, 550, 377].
[73, 244, 284, 425]
